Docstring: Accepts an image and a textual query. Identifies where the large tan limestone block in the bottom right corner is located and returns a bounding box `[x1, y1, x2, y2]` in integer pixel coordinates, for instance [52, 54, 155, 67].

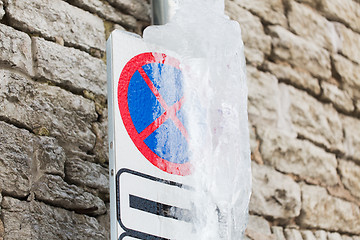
[299, 184, 360, 233]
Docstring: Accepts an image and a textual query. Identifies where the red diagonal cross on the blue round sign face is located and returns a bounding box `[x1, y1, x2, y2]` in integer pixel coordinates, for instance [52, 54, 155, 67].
[138, 67, 188, 140]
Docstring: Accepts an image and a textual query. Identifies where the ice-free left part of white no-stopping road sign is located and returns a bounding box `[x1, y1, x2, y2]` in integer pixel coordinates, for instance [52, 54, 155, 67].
[107, 31, 193, 240]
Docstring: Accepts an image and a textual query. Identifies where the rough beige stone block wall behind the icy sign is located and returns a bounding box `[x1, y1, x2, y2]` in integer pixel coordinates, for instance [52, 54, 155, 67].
[0, 0, 360, 240]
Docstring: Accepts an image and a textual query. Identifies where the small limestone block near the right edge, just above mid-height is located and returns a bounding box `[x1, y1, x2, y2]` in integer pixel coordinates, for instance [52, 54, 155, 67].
[321, 81, 355, 113]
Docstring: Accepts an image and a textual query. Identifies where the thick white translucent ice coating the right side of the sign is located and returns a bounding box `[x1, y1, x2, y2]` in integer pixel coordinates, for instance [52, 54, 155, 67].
[144, 0, 251, 240]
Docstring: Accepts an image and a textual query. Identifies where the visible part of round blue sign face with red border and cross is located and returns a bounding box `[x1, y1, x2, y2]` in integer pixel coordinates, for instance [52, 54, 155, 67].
[118, 52, 190, 176]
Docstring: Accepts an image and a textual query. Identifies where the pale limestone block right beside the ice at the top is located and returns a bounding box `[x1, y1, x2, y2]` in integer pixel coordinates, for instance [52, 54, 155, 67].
[225, 1, 271, 66]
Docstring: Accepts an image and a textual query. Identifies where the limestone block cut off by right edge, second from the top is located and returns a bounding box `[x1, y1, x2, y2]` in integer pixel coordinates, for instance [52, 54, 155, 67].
[335, 23, 360, 64]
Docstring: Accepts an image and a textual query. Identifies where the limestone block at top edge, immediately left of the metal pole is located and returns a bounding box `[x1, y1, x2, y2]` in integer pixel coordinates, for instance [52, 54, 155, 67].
[107, 0, 150, 21]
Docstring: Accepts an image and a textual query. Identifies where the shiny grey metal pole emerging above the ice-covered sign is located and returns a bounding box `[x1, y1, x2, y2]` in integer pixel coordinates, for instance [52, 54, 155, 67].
[151, 0, 179, 25]
